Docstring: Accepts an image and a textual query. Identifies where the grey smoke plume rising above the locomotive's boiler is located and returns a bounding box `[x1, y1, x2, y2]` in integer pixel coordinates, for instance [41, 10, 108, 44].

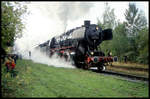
[57, 2, 93, 31]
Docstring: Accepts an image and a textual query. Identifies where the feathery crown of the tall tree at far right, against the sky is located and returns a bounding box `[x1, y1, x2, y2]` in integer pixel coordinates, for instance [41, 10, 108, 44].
[125, 3, 147, 37]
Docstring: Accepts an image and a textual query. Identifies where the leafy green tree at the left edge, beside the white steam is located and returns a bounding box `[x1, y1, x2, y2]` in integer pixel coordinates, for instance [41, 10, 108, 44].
[1, 1, 27, 50]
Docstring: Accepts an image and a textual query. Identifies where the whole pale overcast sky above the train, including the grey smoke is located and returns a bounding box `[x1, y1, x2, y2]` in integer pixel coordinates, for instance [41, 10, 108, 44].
[16, 2, 149, 55]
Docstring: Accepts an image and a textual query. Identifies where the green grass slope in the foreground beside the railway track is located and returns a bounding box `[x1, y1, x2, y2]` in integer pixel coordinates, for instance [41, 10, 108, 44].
[1, 60, 149, 97]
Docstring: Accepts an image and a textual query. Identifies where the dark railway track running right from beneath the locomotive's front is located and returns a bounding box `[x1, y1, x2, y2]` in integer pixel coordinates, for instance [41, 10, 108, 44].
[91, 69, 149, 82]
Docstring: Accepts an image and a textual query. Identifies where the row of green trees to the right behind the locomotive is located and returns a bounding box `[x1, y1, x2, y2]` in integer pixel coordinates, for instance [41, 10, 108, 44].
[98, 3, 149, 64]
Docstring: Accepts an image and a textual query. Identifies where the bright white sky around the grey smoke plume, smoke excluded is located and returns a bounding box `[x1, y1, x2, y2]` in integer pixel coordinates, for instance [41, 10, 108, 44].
[16, 2, 149, 55]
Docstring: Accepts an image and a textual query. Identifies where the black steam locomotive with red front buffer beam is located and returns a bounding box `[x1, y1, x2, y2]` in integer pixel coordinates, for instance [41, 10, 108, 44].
[38, 20, 113, 71]
